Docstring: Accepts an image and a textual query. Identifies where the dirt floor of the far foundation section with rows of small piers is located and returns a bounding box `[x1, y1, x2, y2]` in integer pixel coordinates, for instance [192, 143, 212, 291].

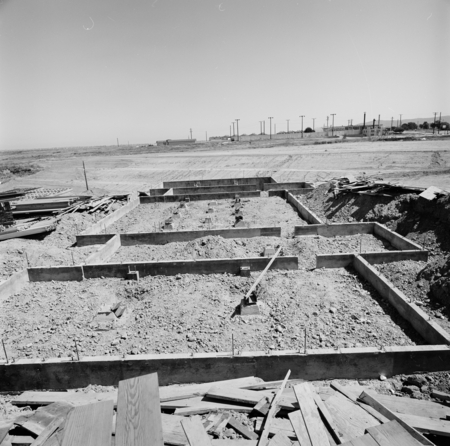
[107, 197, 307, 236]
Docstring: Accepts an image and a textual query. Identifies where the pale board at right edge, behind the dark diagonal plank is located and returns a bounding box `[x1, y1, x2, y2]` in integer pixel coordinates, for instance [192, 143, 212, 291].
[369, 392, 450, 419]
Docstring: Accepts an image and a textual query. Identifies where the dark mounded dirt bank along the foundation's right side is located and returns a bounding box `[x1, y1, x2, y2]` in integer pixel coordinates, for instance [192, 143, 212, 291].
[299, 184, 450, 308]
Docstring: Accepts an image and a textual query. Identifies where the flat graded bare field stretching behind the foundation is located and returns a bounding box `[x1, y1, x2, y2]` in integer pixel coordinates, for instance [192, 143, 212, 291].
[0, 140, 450, 193]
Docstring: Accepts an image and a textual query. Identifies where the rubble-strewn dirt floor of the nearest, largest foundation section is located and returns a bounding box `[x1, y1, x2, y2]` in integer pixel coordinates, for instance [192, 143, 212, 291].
[0, 269, 424, 358]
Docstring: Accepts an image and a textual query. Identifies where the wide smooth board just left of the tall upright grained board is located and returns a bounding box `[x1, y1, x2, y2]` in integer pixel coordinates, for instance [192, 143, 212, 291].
[62, 401, 113, 446]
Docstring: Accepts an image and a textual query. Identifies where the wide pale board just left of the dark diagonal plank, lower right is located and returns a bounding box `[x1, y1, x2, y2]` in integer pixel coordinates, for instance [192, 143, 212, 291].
[324, 393, 380, 439]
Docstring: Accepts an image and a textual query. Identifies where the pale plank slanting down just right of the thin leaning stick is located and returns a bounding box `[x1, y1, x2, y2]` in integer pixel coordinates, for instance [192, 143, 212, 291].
[294, 383, 330, 446]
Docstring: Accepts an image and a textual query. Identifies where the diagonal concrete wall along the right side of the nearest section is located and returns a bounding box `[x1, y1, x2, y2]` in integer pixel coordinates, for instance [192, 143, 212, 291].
[353, 255, 450, 344]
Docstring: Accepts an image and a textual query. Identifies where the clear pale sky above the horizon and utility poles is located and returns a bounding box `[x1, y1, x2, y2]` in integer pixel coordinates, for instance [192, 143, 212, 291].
[0, 0, 450, 150]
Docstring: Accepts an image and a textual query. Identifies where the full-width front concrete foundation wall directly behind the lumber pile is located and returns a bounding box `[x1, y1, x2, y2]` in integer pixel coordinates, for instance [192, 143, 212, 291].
[0, 345, 450, 392]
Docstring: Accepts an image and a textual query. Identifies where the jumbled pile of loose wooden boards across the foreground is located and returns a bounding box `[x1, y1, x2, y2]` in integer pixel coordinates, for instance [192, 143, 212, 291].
[6, 372, 450, 446]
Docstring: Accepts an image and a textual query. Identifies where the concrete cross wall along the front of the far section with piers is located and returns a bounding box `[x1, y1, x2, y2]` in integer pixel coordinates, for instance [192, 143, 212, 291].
[120, 227, 281, 246]
